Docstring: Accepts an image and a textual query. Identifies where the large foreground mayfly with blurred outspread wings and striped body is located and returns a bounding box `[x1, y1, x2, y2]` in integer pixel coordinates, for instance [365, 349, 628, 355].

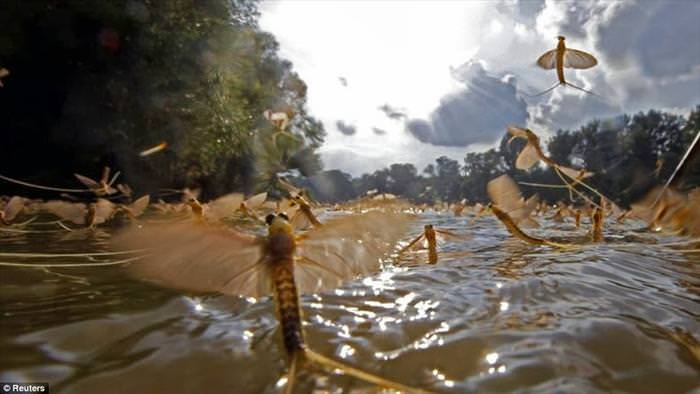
[115, 211, 426, 392]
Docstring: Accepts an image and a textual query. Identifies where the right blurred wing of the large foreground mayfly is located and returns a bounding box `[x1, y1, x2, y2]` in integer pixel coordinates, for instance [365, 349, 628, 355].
[294, 211, 409, 293]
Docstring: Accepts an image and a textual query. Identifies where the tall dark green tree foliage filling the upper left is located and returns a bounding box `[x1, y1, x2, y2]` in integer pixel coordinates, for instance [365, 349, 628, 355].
[0, 0, 324, 195]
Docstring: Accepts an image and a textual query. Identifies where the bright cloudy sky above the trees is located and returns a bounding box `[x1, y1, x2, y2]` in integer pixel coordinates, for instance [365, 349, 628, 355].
[260, 0, 700, 176]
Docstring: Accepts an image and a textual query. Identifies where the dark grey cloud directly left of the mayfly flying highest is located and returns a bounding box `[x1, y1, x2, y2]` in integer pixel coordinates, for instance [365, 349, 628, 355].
[407, 62, 528, 146]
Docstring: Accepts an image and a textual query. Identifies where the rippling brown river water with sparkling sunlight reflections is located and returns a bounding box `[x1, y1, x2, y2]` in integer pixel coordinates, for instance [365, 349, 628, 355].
[0, 214, 700, 393]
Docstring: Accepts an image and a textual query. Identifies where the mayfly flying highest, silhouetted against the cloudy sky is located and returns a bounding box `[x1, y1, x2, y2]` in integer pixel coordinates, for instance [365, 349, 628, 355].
[531, 36, 598, 97]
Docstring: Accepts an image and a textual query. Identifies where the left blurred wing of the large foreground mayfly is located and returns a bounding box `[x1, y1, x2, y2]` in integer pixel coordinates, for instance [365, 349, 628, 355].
[113, 222, 269, 297]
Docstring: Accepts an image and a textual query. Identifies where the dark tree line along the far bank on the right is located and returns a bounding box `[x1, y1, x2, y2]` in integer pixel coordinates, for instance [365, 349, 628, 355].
[297, 106, 700, 206]
